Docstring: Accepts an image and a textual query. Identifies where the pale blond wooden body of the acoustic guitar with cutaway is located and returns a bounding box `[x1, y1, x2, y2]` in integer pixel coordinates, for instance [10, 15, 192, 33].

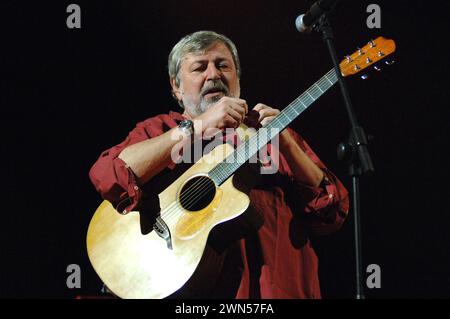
[87, 144, 250, 298]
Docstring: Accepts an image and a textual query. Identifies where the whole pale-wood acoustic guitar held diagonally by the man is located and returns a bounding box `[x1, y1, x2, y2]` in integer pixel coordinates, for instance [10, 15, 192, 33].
[87, 37, 395, 298]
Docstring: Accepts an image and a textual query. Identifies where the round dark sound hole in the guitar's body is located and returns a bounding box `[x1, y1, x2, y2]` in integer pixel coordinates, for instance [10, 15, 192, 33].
[180, 176, 216, 211]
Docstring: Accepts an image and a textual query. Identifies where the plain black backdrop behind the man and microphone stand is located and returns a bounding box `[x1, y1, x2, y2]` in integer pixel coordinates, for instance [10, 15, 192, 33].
[0, 0, 450, 298]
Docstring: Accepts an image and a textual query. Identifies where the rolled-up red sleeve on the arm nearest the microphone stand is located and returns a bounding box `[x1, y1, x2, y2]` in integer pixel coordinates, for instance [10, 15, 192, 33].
[291, 131, 349, 235]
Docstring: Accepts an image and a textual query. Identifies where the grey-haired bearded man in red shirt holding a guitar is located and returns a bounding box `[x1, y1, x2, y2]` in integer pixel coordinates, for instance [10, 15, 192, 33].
[90, 31, 348, 298]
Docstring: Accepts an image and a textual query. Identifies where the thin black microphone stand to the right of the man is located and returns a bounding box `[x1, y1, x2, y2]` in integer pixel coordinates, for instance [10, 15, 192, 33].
[313, 14, 375, 299]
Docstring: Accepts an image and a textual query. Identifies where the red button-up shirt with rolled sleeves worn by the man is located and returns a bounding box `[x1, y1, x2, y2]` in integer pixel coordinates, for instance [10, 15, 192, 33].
[89, 112, 349, 298]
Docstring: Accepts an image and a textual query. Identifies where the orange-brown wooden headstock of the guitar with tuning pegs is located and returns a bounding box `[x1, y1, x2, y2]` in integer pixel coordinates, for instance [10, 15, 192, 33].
[339, 37, 395, 77]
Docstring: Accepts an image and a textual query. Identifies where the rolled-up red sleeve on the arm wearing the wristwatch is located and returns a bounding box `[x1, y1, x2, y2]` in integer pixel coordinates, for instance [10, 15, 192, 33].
[89, 115, 176, 214]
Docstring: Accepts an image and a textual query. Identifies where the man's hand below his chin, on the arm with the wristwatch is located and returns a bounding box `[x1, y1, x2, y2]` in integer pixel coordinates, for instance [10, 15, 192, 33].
[194, 96, 248, 135]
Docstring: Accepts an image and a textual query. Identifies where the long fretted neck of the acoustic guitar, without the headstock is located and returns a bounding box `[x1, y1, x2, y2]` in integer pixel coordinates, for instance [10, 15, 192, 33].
[208, 69, 337, 185]
